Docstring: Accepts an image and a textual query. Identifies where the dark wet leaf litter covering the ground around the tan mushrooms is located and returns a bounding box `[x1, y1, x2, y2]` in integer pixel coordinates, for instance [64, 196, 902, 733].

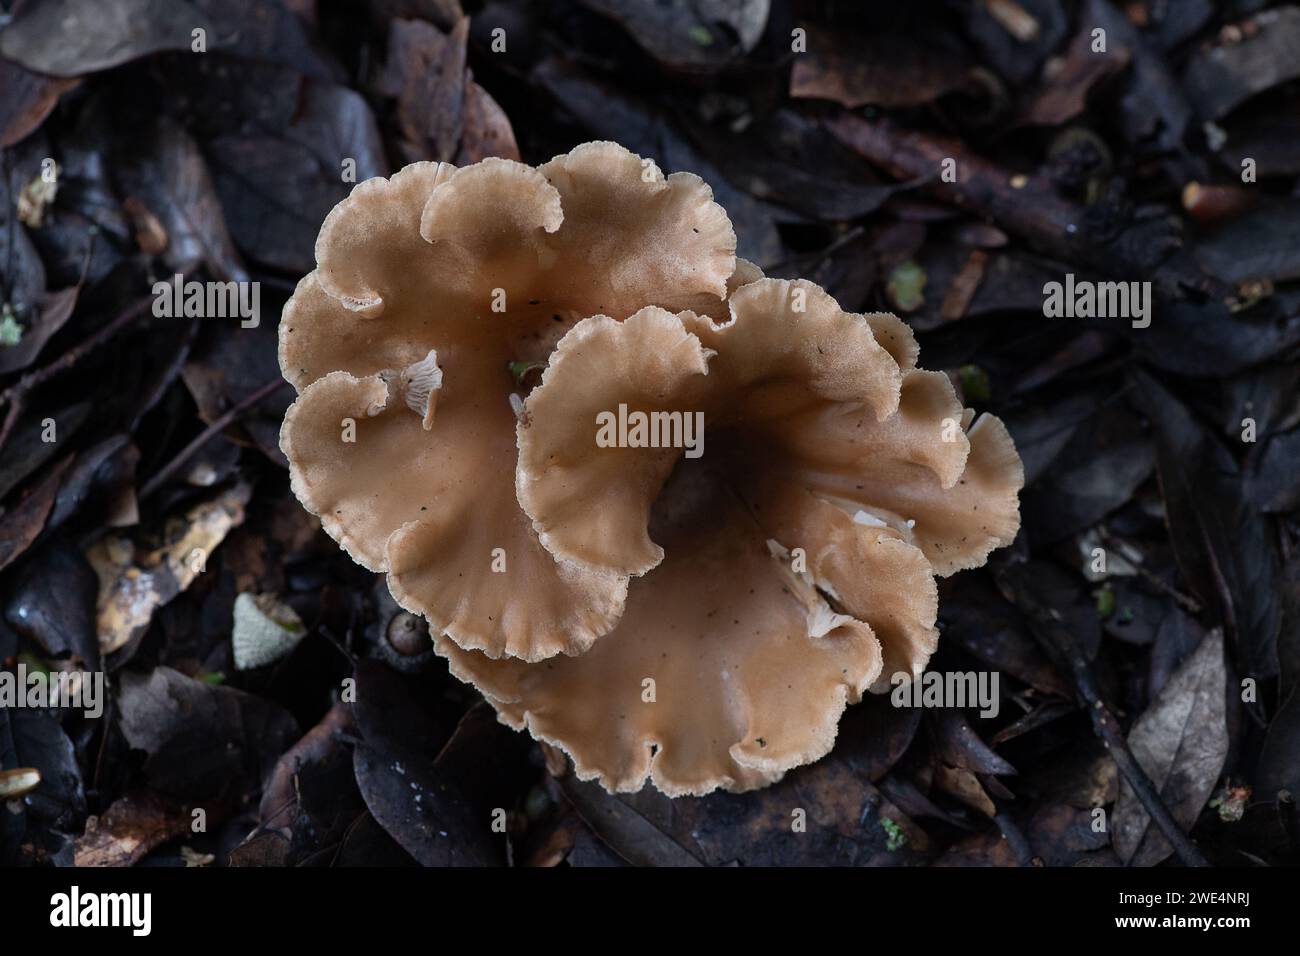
[0, 0, 1300, 866]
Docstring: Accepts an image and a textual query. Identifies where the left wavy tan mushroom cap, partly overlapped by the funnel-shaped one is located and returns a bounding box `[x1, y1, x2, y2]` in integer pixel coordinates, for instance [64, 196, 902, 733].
[280, 143, 733, 661]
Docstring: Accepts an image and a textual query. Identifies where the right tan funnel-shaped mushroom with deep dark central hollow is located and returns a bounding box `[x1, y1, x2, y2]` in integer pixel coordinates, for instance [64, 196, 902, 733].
[434, 278, 1023, 796]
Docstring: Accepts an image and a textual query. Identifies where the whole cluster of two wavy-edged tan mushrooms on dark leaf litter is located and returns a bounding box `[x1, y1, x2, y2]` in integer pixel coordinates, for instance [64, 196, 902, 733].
[280, 143, 1023, 796]
